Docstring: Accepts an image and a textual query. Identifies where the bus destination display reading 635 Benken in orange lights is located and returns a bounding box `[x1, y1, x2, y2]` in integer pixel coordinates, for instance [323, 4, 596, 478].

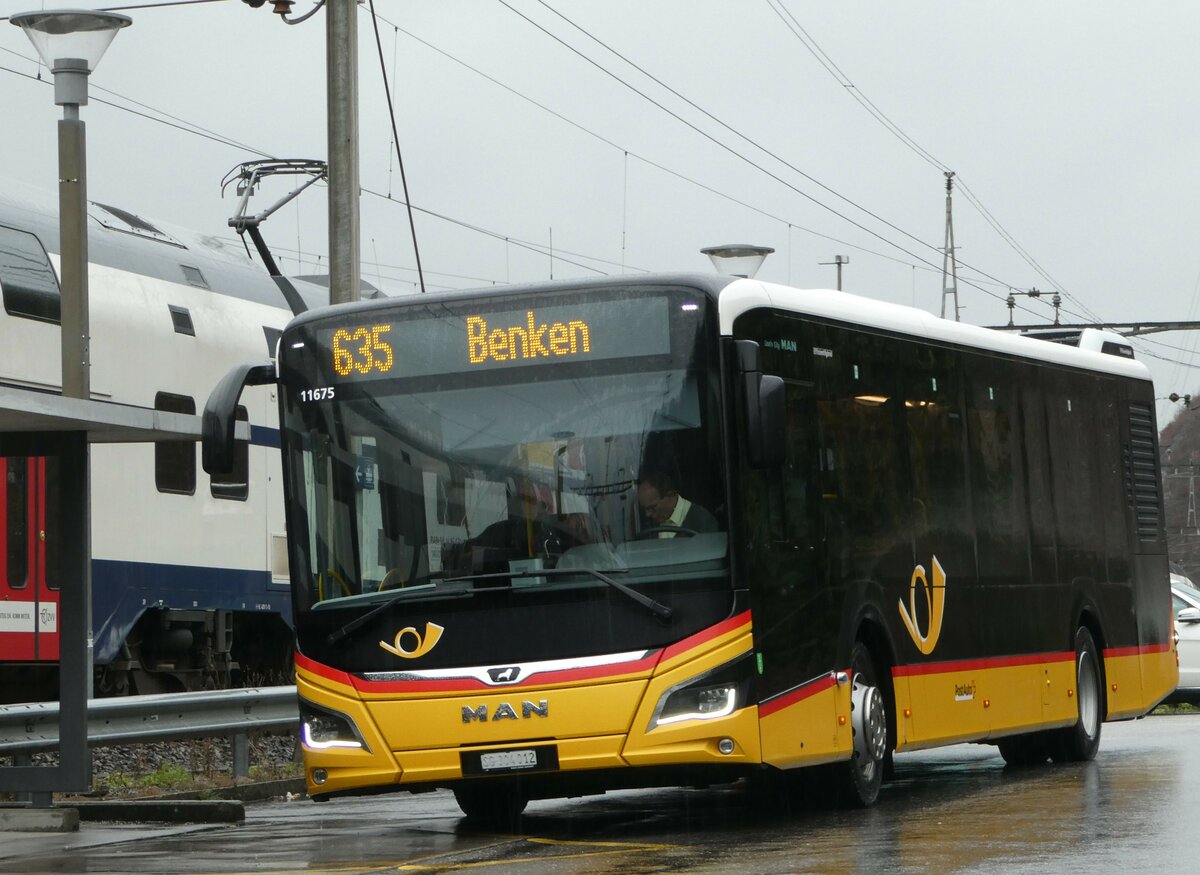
[318, 296, 671, 380]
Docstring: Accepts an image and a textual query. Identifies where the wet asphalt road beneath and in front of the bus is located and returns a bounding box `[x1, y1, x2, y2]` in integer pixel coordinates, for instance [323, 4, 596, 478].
[0, 715, 1200, 875]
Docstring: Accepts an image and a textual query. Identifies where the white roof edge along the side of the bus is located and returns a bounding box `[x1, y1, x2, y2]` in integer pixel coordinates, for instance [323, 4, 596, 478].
[720, 280, 1150, 380]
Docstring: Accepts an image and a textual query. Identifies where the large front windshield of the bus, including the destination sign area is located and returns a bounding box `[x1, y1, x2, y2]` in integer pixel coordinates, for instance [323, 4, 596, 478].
[281, 290, 728, 662]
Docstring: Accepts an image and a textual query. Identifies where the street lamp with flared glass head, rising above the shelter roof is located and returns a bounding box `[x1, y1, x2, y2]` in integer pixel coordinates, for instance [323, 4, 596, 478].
[8, 10, 132, 398]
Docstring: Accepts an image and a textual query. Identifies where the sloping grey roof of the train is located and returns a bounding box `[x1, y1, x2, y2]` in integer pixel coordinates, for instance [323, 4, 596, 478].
[0, 180, 329, 308]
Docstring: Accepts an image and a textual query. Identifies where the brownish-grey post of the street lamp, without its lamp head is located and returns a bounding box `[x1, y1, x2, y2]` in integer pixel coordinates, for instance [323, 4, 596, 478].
[59, 111, 91, 398]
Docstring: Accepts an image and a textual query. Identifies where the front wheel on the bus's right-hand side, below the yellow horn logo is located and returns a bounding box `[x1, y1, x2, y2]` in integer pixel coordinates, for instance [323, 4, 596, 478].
[835, 642, 888, 808]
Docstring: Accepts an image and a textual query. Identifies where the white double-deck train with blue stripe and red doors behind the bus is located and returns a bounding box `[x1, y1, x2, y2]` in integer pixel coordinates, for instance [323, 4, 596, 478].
[0, 185, 328, 701]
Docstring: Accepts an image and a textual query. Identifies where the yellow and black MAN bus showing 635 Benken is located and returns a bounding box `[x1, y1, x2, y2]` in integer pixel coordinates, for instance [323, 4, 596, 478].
[205, 275, 1177, 820]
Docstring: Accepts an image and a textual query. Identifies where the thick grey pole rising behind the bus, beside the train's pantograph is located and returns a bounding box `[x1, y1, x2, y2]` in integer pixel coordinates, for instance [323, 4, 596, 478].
[325, 0, 360, 304]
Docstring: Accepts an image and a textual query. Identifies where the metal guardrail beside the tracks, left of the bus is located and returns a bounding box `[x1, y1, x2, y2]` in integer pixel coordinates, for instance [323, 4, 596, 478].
[0, 687, 300, 778]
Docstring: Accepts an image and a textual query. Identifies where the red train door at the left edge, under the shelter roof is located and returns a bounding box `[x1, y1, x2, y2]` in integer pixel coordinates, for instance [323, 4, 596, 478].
[0, 456, 59, 663]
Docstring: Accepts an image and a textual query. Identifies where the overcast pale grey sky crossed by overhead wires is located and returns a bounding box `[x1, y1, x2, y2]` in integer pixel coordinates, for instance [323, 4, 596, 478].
[0, 0, 1200, 425]
